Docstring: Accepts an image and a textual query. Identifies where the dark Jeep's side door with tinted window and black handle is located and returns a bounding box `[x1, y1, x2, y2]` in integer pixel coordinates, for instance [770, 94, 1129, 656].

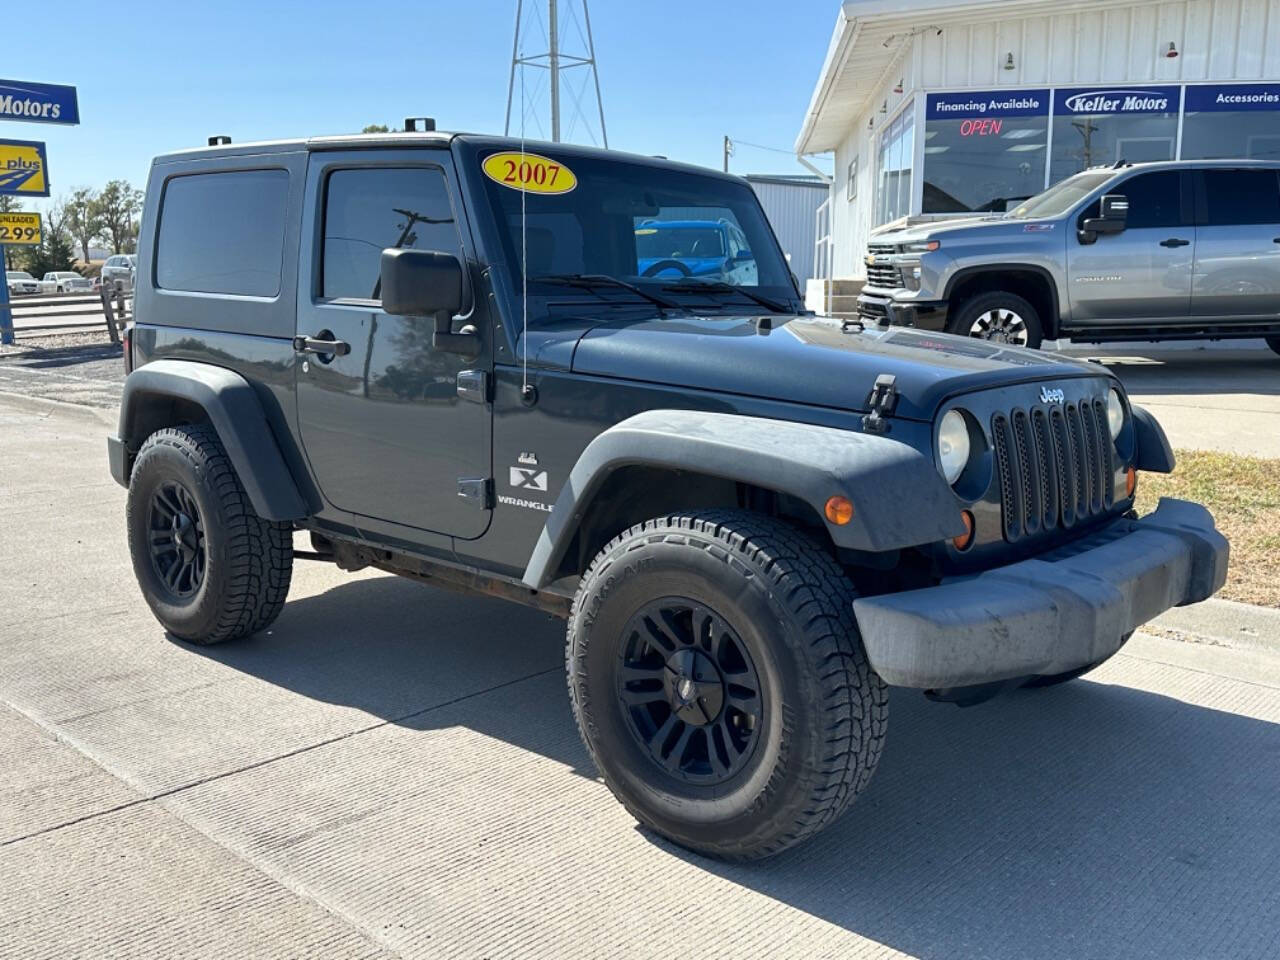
[294, 147, 492, 539]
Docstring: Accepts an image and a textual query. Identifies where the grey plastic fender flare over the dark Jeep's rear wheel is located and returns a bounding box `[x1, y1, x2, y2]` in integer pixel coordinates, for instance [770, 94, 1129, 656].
[109, 360, 310, 520]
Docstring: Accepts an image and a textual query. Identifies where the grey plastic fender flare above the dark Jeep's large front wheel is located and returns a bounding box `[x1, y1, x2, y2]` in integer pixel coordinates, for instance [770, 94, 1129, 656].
[524, 410, 964, 590]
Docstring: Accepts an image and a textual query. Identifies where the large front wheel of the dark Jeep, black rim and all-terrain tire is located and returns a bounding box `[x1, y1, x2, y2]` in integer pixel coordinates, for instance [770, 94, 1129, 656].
[566, 511, 888, 860]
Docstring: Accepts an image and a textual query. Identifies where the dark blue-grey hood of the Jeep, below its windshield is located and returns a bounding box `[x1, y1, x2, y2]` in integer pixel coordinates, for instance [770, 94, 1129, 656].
[565, 316, 1108, 420]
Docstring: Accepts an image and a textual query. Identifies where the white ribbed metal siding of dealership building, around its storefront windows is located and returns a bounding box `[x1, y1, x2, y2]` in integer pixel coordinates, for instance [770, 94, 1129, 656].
[809, 0, 1280, 278]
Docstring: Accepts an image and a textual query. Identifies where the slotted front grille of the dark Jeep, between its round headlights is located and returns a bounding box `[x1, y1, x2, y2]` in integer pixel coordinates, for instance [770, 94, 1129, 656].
[991, 398, 1115, 543]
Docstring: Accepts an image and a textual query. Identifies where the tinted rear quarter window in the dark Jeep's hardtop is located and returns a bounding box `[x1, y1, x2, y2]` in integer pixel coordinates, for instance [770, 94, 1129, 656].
[155, 170, 289, 298]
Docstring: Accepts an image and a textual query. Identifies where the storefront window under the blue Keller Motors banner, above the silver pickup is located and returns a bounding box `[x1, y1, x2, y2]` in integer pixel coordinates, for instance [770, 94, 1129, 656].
[1050, 86, 1180, 183]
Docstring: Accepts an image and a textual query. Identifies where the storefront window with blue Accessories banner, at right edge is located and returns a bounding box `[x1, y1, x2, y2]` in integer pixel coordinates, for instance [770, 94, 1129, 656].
[1183, 83, 1280, 160]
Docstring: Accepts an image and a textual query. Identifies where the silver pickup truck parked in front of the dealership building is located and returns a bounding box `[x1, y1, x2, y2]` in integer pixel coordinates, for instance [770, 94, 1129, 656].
[858, 160, 1280, 353]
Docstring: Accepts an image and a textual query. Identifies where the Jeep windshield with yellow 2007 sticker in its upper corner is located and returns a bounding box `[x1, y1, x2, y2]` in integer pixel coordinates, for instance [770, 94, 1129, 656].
[477, 145, 800, 312]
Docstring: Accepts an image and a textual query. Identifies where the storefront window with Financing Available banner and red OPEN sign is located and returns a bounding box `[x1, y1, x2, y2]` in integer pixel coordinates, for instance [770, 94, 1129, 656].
[922, 90, 1048, 214]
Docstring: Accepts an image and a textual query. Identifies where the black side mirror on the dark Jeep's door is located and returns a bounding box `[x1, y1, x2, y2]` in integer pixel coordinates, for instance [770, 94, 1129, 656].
[379, 250, 480, 353]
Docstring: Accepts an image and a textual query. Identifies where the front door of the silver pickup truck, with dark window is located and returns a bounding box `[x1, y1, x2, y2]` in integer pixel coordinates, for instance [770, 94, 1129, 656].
[1066, 170, 1196, 325]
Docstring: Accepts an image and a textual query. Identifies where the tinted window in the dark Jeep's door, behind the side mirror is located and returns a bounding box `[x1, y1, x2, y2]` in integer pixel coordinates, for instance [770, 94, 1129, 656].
[320, 166, 462, 300]
